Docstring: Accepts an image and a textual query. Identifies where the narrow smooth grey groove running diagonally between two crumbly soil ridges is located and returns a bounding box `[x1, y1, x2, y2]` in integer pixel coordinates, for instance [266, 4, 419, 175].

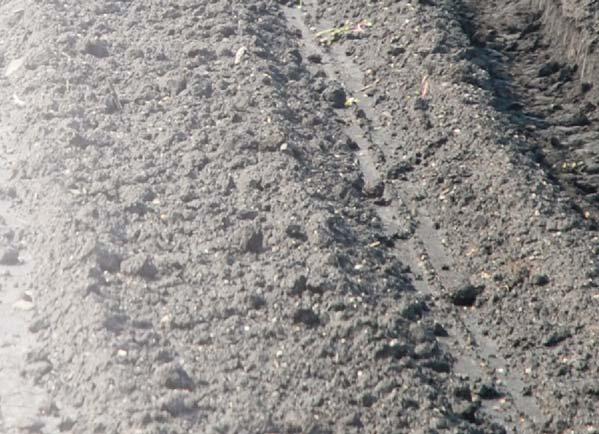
[285, 2, 545, 432]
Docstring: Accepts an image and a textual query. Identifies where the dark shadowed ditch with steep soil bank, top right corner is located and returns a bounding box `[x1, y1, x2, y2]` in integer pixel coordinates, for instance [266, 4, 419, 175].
[451, 0, 599, 224]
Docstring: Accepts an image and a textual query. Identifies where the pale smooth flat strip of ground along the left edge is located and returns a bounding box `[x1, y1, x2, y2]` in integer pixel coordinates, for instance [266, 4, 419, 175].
[0, 124, 60, 434]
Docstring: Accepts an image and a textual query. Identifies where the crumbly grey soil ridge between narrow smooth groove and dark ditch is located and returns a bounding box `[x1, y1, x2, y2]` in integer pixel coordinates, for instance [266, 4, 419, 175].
[300, 1, 598, 432]
